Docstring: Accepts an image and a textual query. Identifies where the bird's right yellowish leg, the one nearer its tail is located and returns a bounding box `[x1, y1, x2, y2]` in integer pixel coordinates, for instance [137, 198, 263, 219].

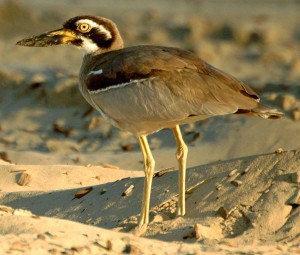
[173, 125, 188, 216]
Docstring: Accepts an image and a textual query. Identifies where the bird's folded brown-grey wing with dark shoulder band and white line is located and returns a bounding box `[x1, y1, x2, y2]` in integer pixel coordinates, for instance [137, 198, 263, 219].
[85, 46, 259, 121]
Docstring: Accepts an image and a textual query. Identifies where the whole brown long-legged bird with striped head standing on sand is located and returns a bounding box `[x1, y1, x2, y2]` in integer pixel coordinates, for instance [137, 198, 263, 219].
[17, 15, 282, 226]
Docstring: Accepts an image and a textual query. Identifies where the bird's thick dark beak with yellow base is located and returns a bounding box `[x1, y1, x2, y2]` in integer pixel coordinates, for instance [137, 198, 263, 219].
[17, 28, 76, 47]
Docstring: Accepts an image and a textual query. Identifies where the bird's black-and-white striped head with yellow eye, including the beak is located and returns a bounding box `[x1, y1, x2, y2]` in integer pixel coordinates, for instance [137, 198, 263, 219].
[17, 16, 123, 53]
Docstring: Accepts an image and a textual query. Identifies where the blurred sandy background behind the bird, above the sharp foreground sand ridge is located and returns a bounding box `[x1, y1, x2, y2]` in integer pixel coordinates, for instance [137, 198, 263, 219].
[0, 0, 300, 169]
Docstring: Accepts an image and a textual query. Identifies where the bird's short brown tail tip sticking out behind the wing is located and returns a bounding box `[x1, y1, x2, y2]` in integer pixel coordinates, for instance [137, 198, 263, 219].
[235, 104, 283, 119]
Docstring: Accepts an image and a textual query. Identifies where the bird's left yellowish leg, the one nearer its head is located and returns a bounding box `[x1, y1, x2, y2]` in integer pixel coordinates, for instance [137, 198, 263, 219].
[138, 135, 155, 226]
